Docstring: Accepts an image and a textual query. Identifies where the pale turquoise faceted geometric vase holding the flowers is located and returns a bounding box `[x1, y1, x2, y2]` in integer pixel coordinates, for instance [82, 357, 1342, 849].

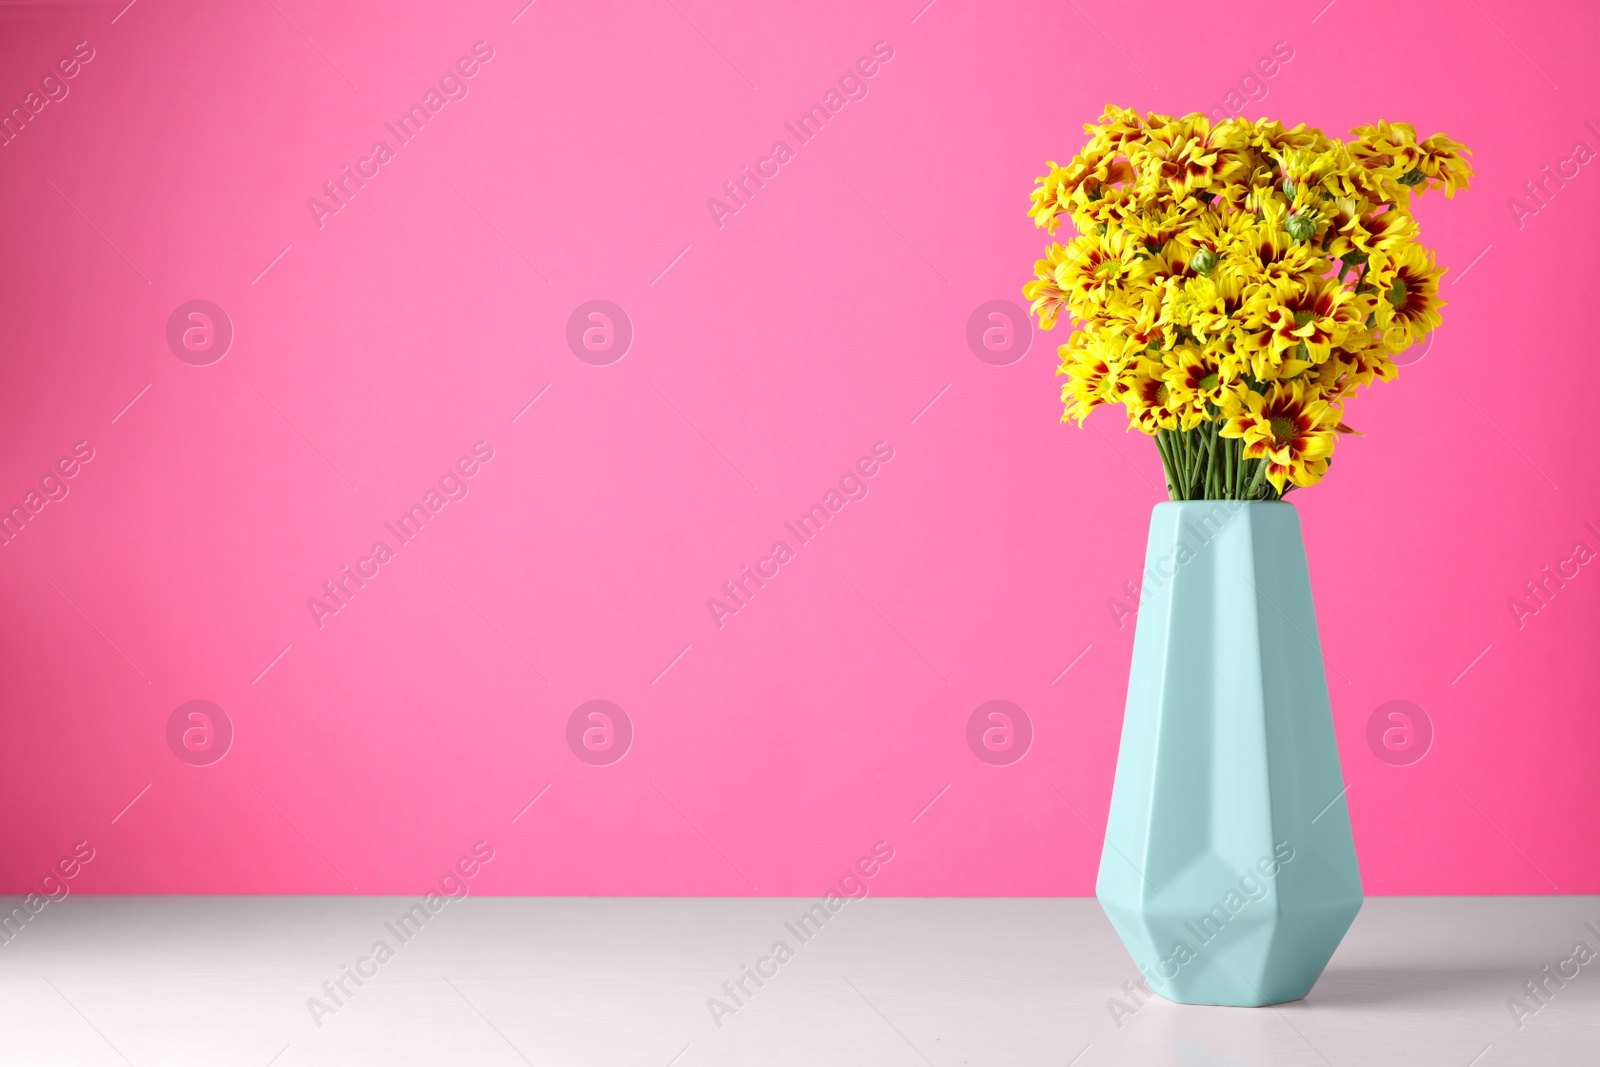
[1094, 501, 1362, 1006]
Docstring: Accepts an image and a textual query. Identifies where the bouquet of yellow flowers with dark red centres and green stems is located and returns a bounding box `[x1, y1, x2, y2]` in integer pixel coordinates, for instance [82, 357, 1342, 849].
[1022, 107, 1472, 501]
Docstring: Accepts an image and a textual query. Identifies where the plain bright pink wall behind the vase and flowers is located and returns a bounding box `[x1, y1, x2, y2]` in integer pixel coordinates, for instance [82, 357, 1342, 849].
[0, 0, 1600, 896]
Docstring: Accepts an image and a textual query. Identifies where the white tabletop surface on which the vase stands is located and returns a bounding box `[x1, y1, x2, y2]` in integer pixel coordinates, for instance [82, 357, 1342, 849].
[0, 896, 1600, 1067]
